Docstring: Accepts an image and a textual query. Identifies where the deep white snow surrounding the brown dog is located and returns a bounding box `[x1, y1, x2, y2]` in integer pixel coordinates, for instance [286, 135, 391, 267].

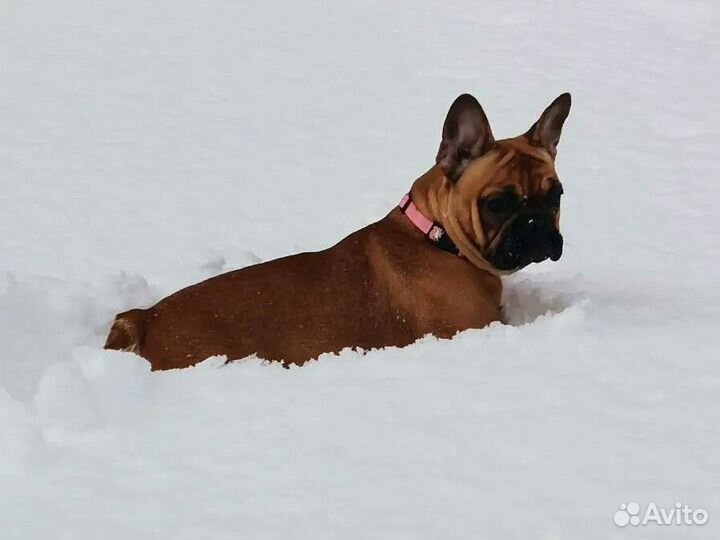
[0, 0, 720, 540]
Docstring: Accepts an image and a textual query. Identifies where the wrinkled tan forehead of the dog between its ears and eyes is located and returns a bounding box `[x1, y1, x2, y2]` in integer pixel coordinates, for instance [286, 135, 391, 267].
[456, 137, 557, 197]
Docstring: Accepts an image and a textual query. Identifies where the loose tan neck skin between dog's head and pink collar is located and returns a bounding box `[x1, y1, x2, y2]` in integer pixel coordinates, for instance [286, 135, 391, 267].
[410, 165, 509, 276]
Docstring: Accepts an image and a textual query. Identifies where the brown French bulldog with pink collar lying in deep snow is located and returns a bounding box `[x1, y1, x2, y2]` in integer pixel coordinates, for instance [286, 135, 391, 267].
[105, 94, 570, 369]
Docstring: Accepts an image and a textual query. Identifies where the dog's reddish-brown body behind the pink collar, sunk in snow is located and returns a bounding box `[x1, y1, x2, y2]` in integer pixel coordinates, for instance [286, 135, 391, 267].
[105, 210, 500, 370]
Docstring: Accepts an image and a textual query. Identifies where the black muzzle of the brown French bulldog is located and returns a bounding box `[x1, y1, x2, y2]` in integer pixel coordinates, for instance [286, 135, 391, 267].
[489, 212, 563, 271]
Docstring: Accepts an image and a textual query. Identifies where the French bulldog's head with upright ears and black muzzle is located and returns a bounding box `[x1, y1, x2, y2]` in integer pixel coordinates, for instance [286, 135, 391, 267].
[436, 94, 570, 273]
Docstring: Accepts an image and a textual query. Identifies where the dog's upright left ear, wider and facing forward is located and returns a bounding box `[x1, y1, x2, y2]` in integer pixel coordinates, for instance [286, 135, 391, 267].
[435, 94, 495, 182]
